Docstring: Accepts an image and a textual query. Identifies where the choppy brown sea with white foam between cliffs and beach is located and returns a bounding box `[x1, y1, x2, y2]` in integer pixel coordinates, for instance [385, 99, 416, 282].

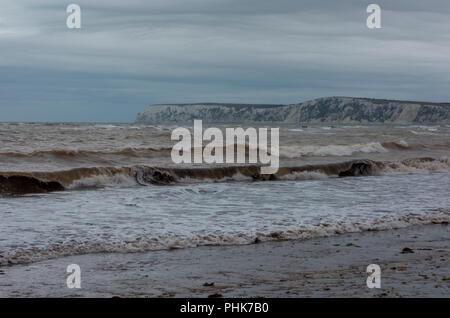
[0, 123, 450, 266]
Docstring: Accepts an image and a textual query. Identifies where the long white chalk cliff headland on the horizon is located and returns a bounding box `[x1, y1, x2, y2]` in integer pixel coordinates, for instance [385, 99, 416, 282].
[136, 97, 450, 124]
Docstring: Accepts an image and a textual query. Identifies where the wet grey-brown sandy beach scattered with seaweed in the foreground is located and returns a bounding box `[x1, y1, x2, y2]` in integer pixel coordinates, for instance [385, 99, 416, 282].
[0, 225, 450, 297]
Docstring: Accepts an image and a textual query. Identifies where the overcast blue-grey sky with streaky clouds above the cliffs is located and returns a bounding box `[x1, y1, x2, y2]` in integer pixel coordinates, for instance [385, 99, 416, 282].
[0, 0, 450, 122]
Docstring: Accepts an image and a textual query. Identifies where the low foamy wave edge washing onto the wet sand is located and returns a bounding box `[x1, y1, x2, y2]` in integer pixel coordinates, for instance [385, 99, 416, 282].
[0, 209, 450, 266]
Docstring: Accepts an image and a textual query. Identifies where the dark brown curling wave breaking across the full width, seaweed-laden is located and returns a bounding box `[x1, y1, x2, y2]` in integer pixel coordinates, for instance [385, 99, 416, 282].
[0, 157, 450, 194]
